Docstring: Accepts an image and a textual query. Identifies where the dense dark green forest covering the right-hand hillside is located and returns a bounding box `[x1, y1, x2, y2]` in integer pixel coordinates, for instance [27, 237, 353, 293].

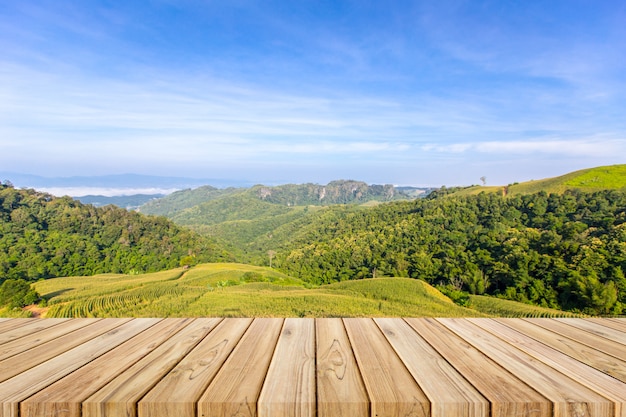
[274, 190, 626, 314]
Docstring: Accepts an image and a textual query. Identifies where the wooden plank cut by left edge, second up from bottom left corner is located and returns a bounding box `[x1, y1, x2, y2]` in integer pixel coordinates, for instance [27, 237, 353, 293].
[0, 319, 130, 382]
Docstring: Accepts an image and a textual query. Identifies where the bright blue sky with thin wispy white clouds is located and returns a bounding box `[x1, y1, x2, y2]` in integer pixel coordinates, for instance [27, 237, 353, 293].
[0, 0, 626, 186]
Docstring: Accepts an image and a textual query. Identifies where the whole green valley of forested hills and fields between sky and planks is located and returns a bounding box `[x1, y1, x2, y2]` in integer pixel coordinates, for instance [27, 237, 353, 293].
[0, 165, 626, 317]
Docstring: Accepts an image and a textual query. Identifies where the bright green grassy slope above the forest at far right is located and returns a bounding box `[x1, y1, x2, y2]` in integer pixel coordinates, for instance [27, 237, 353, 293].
[454, 164, 626, 195]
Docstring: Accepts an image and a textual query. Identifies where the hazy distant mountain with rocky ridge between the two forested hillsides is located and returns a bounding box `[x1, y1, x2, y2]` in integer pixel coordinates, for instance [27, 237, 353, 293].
[139, 180, 427, 262]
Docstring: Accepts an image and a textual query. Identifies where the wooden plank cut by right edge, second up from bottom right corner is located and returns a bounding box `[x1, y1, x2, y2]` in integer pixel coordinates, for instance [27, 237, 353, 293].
[498, 319, 626, 382]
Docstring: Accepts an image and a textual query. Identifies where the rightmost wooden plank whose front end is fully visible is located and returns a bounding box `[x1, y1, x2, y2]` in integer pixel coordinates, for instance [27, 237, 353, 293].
[438, 319, 615, 417]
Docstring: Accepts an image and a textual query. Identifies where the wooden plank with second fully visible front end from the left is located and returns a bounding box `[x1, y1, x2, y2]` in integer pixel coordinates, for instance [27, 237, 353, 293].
[82, 318, 221, 417]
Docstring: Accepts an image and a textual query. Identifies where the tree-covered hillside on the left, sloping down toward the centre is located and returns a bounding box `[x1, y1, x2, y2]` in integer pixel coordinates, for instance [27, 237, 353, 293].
[0, 183, 226, 281]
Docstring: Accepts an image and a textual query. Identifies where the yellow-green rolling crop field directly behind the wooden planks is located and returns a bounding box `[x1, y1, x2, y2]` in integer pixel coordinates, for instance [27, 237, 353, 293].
[8, 264, 576, 317]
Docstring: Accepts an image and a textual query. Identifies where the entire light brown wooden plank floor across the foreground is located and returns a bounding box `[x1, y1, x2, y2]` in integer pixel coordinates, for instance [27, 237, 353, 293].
[0, 318, 626, 417]
